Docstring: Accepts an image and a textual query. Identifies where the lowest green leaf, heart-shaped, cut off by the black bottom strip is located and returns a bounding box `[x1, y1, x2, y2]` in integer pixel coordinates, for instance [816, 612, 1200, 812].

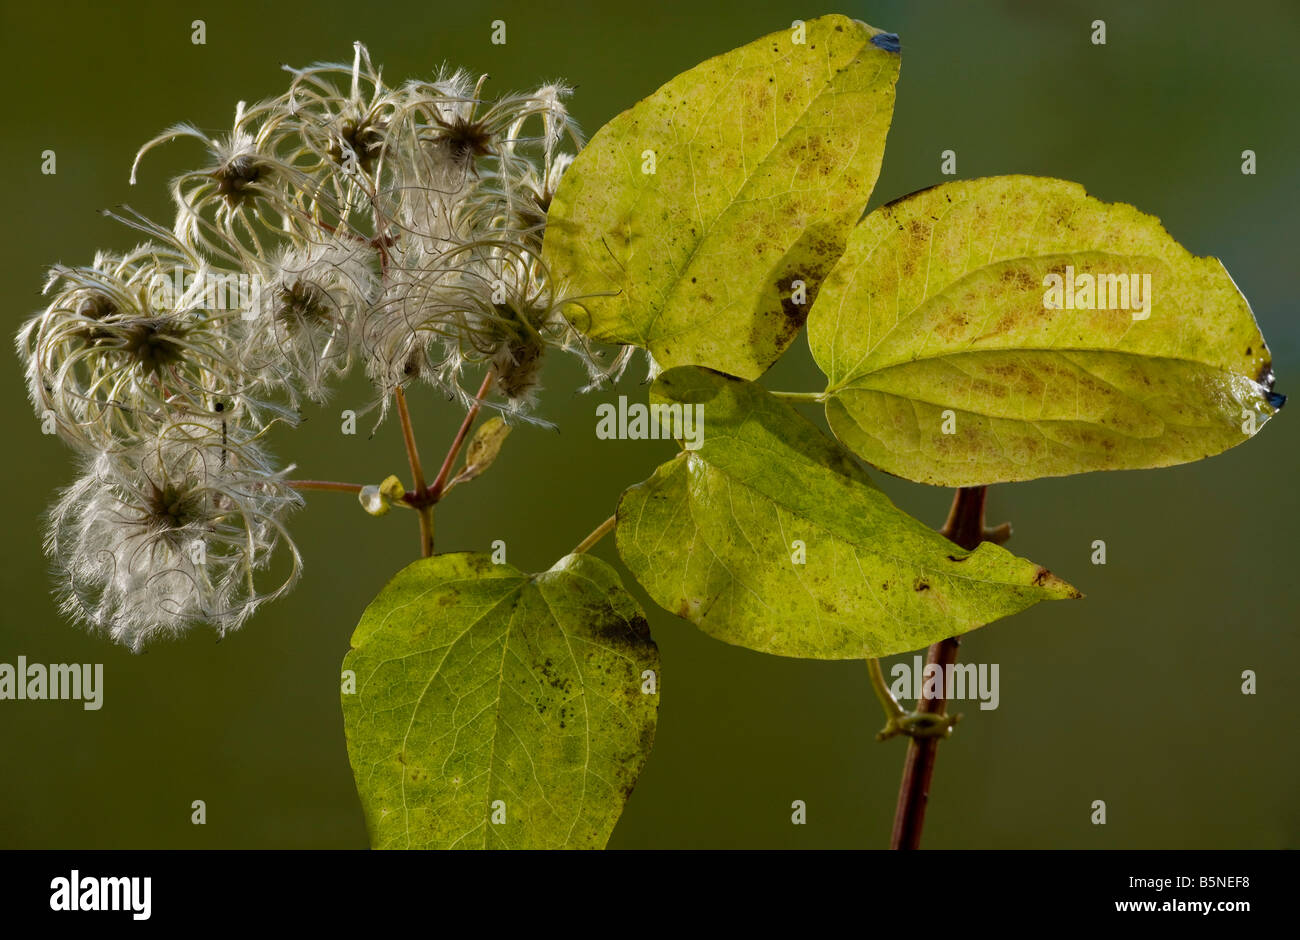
[343, 554, 659, 849]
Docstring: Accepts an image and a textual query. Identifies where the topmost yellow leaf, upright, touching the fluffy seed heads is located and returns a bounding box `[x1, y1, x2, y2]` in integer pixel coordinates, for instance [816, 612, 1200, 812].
[545, 16, 898, 377]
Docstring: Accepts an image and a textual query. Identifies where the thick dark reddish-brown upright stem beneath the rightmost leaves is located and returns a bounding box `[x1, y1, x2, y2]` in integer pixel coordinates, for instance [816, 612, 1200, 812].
[889, 486, 987, 849]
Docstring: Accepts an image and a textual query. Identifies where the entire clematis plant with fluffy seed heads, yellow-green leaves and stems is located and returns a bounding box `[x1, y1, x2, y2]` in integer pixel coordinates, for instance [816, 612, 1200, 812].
[18, 16, 1284, 848]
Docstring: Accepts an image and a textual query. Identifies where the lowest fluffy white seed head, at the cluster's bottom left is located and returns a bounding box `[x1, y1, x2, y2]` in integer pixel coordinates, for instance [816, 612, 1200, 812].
[46, 424, 300, 650]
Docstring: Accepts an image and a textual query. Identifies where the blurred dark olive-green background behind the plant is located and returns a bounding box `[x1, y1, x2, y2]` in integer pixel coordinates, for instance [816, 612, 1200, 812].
[0, 0, 1300, 848]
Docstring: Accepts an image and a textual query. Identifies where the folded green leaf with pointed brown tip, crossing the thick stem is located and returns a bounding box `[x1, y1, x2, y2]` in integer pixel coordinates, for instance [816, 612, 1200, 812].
[616, 367, 1079, 659]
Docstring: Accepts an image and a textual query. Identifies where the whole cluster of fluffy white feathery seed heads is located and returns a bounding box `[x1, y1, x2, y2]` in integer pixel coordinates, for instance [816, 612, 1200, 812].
[17, 43, 613, 650]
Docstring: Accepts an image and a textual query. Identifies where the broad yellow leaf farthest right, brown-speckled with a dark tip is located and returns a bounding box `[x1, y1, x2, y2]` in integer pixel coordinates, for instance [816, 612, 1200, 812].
[809, 176, 1284, 486]
